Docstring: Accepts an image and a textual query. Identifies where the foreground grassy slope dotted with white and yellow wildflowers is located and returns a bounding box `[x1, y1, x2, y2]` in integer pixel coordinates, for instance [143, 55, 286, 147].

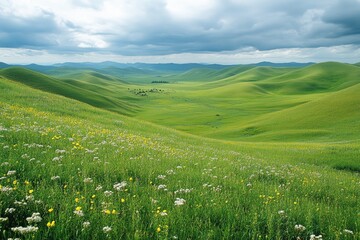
[0, 79, 360, 239]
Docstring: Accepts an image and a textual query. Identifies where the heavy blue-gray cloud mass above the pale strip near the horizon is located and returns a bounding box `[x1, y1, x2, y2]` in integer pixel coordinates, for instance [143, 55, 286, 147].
[0, 0, 360, 60]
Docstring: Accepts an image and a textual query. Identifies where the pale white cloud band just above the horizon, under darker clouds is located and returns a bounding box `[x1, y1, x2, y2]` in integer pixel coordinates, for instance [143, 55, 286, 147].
[0, 45, 360, 64]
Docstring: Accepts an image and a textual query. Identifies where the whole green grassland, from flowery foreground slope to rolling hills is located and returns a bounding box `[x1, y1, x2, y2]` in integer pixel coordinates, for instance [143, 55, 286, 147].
[0, 63, 360, 239]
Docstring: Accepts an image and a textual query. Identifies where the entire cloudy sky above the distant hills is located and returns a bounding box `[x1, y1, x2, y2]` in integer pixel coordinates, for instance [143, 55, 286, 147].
[0, 0, 360, 64]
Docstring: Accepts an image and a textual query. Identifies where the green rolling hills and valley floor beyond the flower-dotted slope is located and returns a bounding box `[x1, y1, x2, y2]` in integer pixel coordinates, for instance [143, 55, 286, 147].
[0, 62, 360, 142]
